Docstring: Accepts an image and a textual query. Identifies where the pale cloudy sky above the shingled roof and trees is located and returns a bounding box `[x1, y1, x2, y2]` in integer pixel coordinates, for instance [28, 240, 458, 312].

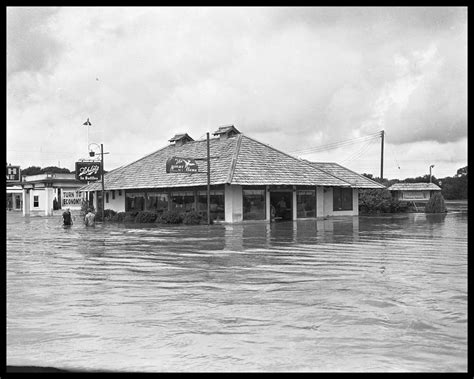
[6, 7, 467, 179]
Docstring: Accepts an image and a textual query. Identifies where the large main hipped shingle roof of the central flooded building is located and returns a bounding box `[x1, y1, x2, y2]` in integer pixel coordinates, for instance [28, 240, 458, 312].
[81, 134, 350, 191]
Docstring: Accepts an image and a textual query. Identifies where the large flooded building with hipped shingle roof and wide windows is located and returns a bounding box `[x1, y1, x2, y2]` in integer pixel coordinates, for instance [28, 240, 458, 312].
[81, 125, 385, 222]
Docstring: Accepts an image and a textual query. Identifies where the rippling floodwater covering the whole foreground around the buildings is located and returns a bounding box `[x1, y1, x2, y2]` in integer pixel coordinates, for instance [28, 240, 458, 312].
[7, 205, 467, 372]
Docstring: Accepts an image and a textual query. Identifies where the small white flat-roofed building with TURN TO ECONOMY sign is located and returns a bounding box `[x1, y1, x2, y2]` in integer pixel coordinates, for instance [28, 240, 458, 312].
[21, 174, 84, 216]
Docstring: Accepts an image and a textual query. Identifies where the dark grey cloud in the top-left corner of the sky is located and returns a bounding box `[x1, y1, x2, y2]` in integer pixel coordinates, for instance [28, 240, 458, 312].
[7, 7, 61, 75]
